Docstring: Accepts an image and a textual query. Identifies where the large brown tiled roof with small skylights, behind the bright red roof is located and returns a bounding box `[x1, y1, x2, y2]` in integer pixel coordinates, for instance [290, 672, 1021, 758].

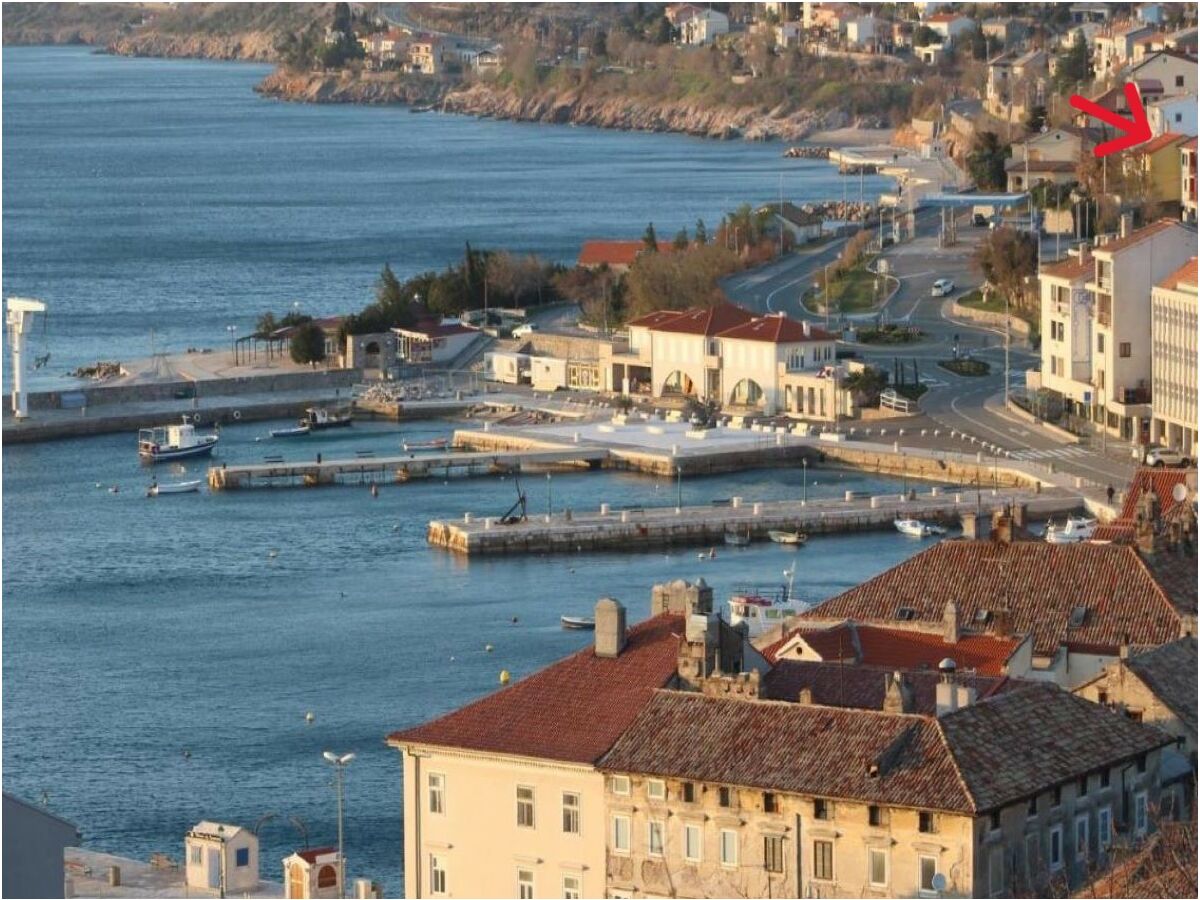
[800, 540, 1195, 655]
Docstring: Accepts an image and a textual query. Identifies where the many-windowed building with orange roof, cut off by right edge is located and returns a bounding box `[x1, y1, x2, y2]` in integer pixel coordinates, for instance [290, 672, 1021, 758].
[1150, 260, 1198, 458]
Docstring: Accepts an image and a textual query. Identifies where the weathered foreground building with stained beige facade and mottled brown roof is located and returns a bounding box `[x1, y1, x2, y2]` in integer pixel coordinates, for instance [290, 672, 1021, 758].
[599, 686, 1171, 898]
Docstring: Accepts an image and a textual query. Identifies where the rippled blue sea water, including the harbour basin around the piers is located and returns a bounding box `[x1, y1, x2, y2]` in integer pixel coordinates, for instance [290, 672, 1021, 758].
[2, 48, 920, 893]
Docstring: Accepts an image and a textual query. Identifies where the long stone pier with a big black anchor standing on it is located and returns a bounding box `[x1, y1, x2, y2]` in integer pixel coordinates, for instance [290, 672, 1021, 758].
[427, 490, 1082, 554]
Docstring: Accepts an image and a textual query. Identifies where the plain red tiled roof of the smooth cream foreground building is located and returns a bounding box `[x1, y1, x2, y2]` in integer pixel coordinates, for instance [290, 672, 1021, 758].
[388, 614, 684, 763]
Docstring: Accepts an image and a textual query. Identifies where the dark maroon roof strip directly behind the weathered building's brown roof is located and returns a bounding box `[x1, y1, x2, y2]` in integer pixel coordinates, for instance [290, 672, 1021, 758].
[760, 659, 1024, 715]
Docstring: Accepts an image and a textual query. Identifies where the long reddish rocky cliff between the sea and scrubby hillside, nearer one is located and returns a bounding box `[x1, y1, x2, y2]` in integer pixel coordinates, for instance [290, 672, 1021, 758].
[256, 70, 880, 140]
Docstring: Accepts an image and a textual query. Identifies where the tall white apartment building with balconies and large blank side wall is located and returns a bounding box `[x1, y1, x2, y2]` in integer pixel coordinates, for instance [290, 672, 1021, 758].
[1086, 217, 1196, 440]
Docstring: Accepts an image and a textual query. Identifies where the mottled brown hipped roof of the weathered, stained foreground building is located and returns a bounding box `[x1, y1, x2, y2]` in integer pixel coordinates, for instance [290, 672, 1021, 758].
[599, 684, 1172, 815]
